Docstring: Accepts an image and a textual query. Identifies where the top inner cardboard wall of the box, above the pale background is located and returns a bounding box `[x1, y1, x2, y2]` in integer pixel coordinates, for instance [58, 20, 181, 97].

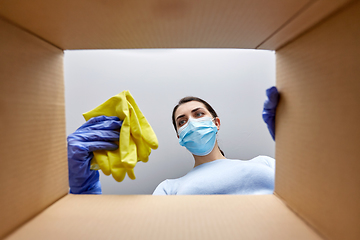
[0, 0, 310, 49]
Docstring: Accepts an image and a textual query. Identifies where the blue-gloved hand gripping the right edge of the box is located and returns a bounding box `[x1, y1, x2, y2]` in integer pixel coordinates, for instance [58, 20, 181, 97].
[263, 87, 279, 140]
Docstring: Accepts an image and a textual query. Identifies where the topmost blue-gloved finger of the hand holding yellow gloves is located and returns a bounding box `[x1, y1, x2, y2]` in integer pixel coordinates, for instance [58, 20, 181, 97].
[76, 116, 122, 131]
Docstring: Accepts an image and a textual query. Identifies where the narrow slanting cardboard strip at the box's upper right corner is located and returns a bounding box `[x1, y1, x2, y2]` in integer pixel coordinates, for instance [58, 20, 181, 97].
[258, 0, 351, 50]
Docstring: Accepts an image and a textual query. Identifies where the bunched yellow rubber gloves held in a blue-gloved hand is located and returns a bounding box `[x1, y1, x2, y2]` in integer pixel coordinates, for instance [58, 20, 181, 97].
[83, 90, 159, 182]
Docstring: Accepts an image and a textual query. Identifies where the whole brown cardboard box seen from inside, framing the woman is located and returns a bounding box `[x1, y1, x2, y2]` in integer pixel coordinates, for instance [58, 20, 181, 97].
[0, 0, 360, 239]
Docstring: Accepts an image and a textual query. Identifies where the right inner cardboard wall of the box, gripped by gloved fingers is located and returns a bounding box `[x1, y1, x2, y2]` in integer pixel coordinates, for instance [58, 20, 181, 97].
[275, 1, 360, 239]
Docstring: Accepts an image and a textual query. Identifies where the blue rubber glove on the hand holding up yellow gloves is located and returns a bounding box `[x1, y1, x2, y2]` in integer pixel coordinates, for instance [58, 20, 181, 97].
[67, 116, 122, 194]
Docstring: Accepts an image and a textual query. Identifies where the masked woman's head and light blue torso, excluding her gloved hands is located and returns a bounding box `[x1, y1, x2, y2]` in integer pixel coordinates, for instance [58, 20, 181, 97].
[153, 97, 275, 195]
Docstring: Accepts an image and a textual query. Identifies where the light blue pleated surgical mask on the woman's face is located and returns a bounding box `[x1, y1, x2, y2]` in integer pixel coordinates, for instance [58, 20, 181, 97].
[178, 117, 218, 156]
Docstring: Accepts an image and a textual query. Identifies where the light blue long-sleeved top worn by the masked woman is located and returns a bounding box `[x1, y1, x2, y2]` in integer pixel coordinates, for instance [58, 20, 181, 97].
[153, 156, 275, 195]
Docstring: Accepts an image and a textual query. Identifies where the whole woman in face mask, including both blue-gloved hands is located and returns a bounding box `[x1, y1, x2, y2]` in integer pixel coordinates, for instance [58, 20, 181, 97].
[68, 87, 279, 195]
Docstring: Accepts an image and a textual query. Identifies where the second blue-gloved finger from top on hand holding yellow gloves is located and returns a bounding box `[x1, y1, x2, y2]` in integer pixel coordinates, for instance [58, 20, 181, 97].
[68, 130, 120, 145]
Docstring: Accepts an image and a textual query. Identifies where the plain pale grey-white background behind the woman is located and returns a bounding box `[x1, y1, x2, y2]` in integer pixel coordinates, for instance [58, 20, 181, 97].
[65, 49, 275, 194]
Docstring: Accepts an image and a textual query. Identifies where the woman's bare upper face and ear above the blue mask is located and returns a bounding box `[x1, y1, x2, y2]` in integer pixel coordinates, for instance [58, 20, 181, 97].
[175, 101, 220, 137]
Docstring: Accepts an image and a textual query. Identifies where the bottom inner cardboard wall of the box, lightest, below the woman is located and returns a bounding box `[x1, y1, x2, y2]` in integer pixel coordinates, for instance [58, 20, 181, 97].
[7, 195, 321, 240]
